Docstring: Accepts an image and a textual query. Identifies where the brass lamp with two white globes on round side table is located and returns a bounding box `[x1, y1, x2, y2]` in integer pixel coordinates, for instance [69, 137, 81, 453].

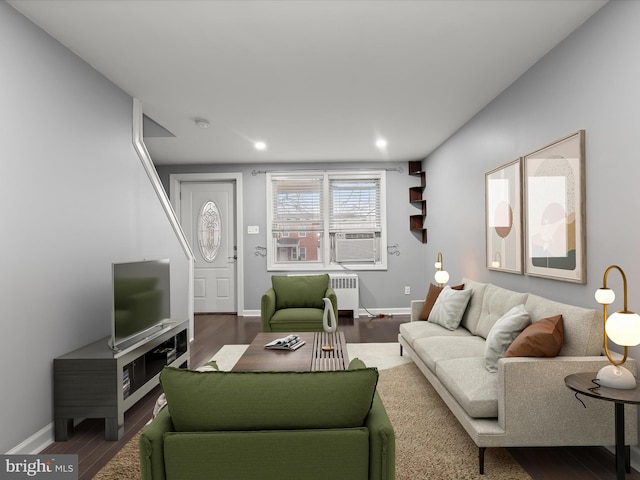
[595, 265, 640, 390]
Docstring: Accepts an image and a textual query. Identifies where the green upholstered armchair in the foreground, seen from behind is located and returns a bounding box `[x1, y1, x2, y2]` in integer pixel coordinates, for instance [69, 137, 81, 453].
[140, 359, 395, 480]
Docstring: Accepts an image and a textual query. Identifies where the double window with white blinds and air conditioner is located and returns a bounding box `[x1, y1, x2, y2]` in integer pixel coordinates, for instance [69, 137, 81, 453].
[267, 171, 387, 270]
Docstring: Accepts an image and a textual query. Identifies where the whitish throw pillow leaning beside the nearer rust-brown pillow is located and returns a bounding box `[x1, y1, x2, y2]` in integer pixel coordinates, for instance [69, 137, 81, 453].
[484, 305, 531, 373]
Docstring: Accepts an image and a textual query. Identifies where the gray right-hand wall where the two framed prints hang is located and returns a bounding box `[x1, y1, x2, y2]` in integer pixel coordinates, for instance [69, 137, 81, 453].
[424, 1, 640, 359]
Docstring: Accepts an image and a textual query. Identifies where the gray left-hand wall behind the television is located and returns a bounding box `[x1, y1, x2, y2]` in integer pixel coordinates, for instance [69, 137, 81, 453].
[0, 2, 187, 453]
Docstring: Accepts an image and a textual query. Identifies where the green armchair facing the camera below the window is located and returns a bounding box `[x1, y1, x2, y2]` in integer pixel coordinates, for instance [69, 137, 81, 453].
[260, 274, 338, 332]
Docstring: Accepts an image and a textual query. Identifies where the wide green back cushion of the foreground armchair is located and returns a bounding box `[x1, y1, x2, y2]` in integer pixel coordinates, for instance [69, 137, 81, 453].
[160, 367, 378, 432]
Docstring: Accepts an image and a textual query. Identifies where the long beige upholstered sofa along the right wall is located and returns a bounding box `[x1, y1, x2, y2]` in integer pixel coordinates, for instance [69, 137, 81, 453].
[398, 279, 637, 473]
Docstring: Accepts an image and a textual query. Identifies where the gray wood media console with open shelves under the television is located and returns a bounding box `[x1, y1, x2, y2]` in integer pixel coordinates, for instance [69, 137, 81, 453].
[53, 320, 189, 442]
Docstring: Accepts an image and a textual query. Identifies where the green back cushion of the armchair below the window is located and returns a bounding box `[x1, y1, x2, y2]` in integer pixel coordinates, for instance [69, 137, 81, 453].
[271, 274, 329, 310]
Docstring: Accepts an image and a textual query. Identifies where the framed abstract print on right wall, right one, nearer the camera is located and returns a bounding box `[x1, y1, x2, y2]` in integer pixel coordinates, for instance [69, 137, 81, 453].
[523, 130, 587, 283]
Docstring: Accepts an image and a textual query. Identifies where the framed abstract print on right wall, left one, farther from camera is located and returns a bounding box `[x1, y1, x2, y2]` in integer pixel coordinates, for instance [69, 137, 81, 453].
[485, 158, 523, 274]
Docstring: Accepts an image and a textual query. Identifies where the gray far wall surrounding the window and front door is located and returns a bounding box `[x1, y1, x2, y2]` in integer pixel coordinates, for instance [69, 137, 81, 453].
[157, 162, 424, 313]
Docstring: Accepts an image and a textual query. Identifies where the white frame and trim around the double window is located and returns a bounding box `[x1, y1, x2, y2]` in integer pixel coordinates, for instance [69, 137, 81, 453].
[266, 169, 388, 272]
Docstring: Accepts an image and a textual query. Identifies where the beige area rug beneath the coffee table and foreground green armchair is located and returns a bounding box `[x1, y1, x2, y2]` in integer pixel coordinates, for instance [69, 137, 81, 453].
[94, 350, 531, 480]
